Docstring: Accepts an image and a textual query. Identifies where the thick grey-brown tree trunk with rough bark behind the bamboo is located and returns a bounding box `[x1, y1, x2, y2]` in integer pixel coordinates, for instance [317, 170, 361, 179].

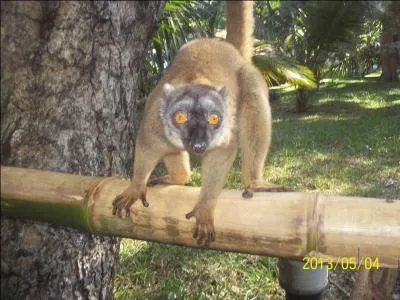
[1, 1, 162, 299]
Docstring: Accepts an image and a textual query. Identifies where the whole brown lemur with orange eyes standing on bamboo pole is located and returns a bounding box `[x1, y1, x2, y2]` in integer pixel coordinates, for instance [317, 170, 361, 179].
[113, 1, 279, 245]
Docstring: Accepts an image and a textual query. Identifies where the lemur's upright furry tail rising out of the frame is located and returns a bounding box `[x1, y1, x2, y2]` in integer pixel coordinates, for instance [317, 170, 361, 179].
[225, 0, 254, 61]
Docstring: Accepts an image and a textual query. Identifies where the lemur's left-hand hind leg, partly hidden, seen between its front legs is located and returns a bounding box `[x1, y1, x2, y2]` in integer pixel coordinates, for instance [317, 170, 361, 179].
[148, 151, 190, 185]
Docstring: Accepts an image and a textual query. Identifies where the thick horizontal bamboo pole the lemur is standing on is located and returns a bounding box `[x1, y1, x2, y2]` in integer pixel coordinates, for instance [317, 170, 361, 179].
[1, 167, 400, 268]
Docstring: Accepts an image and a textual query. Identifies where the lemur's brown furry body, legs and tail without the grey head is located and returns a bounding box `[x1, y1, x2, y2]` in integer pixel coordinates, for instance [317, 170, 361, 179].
[113, 1, 282, 245]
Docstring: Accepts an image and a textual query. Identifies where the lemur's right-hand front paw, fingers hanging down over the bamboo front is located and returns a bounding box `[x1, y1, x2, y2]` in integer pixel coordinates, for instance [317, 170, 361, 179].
[186, 206, 215, 247]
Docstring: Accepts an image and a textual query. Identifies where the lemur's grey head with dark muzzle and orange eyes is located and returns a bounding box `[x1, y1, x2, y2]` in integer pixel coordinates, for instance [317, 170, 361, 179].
[160, 84, 227, 154]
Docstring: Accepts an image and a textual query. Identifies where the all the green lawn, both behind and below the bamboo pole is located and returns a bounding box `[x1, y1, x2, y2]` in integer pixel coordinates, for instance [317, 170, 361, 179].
[114, 78, 400, 299]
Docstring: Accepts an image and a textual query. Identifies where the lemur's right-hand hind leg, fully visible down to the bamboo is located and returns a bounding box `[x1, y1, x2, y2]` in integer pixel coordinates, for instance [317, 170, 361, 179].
[238, 64, 285, 198]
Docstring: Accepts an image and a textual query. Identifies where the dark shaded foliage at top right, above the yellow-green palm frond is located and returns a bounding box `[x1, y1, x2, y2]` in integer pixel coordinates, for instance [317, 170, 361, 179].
[255, 1, 385, 80]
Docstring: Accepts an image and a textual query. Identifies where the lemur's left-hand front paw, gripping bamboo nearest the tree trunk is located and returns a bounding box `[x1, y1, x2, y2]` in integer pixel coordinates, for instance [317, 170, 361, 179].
[112, 185, 149, 218]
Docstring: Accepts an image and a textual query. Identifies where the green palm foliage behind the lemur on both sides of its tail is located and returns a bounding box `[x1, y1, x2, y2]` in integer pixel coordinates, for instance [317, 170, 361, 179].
[142, 0, 385, 111]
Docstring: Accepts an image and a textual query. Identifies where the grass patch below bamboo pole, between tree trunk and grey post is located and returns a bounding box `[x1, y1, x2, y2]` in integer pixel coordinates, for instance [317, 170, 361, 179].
[114, 239, 281, 299]
